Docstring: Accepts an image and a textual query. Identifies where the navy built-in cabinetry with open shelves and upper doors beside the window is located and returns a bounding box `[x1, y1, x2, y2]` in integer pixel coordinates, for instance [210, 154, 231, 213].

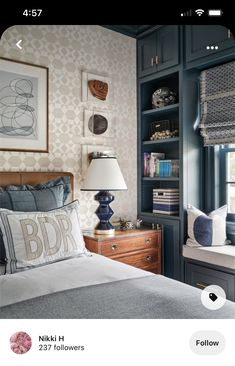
[137, 25, 235, 280]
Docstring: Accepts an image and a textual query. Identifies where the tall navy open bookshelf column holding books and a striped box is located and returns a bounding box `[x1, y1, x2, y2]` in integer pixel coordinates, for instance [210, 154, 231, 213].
[138, 71, 183, 278]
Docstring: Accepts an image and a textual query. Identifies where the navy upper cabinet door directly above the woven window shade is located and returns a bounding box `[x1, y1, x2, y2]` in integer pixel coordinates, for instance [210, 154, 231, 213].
[186, 25, 235, 62]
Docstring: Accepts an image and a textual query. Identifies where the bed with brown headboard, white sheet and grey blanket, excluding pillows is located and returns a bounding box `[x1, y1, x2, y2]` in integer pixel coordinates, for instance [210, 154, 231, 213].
[0, 172, 235, 319]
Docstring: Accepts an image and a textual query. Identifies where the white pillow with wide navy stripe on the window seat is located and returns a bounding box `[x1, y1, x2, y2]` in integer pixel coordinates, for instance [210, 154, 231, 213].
[186, 205, 227, 247]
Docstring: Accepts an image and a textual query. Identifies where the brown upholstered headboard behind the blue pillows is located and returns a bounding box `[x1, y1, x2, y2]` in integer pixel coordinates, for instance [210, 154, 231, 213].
[0, 172, 74, 200]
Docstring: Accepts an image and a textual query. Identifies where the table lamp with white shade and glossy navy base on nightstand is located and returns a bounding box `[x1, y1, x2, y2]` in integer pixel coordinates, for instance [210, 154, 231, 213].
[81, 156, 127, 235]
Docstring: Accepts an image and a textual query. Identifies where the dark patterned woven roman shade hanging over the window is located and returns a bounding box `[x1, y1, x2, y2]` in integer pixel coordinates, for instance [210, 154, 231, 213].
[199, 61, 235, 146]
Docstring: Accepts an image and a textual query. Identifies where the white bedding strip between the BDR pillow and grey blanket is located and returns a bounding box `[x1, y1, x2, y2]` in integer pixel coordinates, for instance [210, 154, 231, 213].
[0, 254, 152, 306]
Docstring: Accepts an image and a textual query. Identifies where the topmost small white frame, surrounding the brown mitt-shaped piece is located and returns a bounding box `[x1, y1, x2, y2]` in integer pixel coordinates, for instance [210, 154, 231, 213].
[82, 71, 113, 107]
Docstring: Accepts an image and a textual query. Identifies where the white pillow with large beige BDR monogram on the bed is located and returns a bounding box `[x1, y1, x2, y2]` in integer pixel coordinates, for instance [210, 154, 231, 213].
[0, 201, 87, 273]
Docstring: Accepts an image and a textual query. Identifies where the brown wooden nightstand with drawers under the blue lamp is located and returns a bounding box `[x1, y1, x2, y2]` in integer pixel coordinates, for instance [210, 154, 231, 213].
[84, 229, 161, 273]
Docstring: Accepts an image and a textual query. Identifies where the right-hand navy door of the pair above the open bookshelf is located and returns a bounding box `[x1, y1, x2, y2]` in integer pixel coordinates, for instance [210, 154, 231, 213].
[155, 25, 179, 71]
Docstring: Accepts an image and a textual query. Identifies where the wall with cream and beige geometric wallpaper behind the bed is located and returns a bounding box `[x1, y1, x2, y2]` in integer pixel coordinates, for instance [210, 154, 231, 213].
[0, 25, 137, 228]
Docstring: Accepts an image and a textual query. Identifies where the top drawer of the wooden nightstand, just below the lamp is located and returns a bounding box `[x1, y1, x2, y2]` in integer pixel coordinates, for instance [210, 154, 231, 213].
[99, 234, 160, 257]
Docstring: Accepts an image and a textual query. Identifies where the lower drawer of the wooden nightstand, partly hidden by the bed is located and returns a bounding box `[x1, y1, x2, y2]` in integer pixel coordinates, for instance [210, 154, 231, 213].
[112, 249, 161, 273]
